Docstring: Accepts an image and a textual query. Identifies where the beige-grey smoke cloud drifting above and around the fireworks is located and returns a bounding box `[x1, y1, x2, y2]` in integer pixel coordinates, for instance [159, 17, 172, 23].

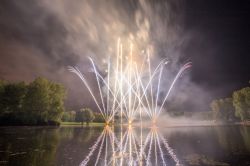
[0, 0, 212, 110]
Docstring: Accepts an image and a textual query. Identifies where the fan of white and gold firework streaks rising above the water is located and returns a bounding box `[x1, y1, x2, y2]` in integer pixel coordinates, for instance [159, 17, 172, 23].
[69, 40, 191, 123]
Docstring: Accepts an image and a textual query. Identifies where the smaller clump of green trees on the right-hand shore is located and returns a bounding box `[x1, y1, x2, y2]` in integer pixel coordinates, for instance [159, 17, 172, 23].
[210, 87, 250, 122]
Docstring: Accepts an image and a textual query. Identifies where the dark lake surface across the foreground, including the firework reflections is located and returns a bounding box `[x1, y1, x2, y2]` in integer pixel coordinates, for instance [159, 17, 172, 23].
[0, 126, 250, 166]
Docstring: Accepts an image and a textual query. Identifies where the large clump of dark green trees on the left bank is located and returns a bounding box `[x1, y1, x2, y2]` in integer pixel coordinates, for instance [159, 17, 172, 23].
[0, 77, 66, 125]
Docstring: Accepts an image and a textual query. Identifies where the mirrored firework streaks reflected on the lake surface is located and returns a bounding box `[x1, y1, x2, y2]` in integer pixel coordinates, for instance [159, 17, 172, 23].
[80, 126, 181, 166]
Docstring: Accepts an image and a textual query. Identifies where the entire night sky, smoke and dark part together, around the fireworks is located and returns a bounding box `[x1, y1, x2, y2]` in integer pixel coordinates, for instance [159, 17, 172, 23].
[0, 0, 250, 111]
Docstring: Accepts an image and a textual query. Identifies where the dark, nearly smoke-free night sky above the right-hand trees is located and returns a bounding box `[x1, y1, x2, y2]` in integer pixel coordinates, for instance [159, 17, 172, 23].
[185, 0, 250, 96]
